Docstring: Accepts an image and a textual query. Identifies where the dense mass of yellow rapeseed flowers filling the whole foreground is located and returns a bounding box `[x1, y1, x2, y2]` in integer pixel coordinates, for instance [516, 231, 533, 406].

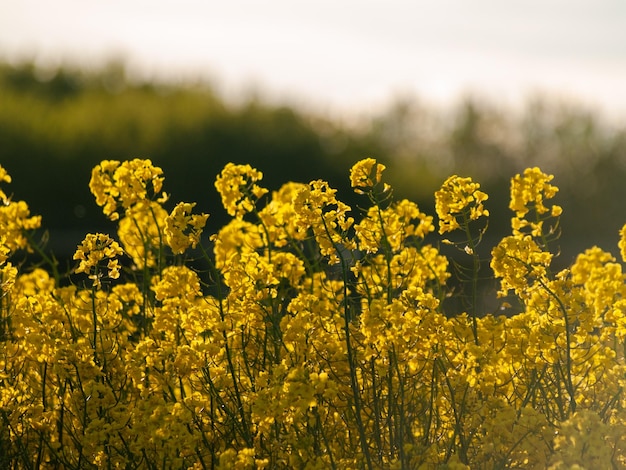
[0, 158, 626, 470]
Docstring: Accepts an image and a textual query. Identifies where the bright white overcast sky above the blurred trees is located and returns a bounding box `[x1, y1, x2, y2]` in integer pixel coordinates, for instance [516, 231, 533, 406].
[0, 0, 626, 123]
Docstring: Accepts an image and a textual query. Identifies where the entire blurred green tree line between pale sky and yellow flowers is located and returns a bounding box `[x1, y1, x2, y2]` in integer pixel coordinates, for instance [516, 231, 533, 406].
[0, 63, 626, 270]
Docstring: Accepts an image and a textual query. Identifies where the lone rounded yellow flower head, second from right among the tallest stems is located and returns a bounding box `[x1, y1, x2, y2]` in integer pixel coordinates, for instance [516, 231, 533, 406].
[435, 175, 489, 234]
